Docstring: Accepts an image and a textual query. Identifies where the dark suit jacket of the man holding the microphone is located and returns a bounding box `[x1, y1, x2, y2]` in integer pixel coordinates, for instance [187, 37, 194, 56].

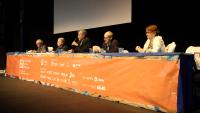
[74, 38, 91, 53]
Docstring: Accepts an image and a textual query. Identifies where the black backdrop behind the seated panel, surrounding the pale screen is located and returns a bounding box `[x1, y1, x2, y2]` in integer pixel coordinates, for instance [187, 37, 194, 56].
[0, 0, 200, 69]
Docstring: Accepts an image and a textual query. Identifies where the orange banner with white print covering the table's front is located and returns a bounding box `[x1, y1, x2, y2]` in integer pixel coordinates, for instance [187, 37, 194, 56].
[6, 54, 179, 112]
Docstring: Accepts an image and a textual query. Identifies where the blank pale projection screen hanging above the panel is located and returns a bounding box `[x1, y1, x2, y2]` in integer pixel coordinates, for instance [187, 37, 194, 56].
[54, 0, 131, 34]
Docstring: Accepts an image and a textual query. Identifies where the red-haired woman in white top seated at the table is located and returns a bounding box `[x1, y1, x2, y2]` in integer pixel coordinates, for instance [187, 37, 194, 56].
[135, 25, 165, 53]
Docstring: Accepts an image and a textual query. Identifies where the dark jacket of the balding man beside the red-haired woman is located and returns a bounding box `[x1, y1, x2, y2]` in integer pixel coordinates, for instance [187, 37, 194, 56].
[102, 39, 119, 53]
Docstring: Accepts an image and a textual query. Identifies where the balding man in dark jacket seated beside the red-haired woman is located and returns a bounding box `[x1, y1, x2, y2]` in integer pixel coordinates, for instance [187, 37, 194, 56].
[93, 31, 119, 53]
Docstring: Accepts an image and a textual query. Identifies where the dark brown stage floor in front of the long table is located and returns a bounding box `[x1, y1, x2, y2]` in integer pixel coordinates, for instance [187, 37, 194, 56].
[0, 76, 159, 113]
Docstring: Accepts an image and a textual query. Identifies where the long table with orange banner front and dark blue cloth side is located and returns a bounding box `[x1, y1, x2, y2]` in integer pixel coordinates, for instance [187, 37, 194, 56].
[6, 52, 194, 112]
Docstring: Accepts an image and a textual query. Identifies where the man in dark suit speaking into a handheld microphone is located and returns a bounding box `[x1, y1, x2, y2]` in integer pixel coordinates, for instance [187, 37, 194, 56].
[72, 30, 91, 53]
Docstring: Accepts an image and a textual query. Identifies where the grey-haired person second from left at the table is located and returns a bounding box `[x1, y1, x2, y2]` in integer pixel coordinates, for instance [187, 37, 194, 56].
[55, 37, 68, 53]
